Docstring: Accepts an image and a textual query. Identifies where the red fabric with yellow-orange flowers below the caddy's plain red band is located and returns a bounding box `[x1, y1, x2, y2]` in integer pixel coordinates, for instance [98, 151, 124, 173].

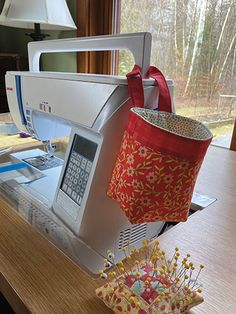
[107, 131, 202, 224]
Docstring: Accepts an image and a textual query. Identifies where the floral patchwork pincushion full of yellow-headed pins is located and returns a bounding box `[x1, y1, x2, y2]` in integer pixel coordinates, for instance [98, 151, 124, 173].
[96, 242, 204, 314]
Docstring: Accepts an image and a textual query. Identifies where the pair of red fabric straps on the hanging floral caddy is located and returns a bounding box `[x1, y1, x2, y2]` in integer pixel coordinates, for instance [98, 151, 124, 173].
[126, 65, 172, 112]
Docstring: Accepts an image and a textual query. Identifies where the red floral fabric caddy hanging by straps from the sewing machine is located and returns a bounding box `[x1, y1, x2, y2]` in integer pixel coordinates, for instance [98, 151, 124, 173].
[107, 66, 212, 224]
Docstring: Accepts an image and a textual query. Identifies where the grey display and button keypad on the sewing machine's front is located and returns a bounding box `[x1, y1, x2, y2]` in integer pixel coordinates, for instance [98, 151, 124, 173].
[60, 134, 97, 205]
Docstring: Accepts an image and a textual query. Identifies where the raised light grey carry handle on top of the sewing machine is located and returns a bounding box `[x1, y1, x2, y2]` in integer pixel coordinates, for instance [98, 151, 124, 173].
[28, 32, 152, 77]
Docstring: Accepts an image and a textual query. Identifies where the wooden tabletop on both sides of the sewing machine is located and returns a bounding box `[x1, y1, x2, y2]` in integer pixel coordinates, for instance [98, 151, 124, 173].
[0, 147, 236, 314]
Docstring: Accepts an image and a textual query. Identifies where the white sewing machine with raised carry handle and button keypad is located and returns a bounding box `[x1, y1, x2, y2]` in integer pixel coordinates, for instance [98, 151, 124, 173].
[2, 33, 173, 273]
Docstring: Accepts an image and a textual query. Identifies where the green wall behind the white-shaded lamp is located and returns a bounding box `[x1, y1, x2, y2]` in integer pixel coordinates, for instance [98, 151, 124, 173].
[0, 0, 77, 72]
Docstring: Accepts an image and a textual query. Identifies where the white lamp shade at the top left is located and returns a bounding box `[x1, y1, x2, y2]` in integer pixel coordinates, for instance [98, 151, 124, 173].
[0, 0, 76, 30]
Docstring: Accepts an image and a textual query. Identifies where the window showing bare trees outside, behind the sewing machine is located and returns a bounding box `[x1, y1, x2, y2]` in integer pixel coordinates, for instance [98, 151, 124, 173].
[116, 0, 236, 147]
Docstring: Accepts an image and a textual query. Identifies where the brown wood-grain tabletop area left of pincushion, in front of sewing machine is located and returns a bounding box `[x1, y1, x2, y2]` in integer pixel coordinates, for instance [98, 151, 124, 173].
[0, 194, 111, 313]
